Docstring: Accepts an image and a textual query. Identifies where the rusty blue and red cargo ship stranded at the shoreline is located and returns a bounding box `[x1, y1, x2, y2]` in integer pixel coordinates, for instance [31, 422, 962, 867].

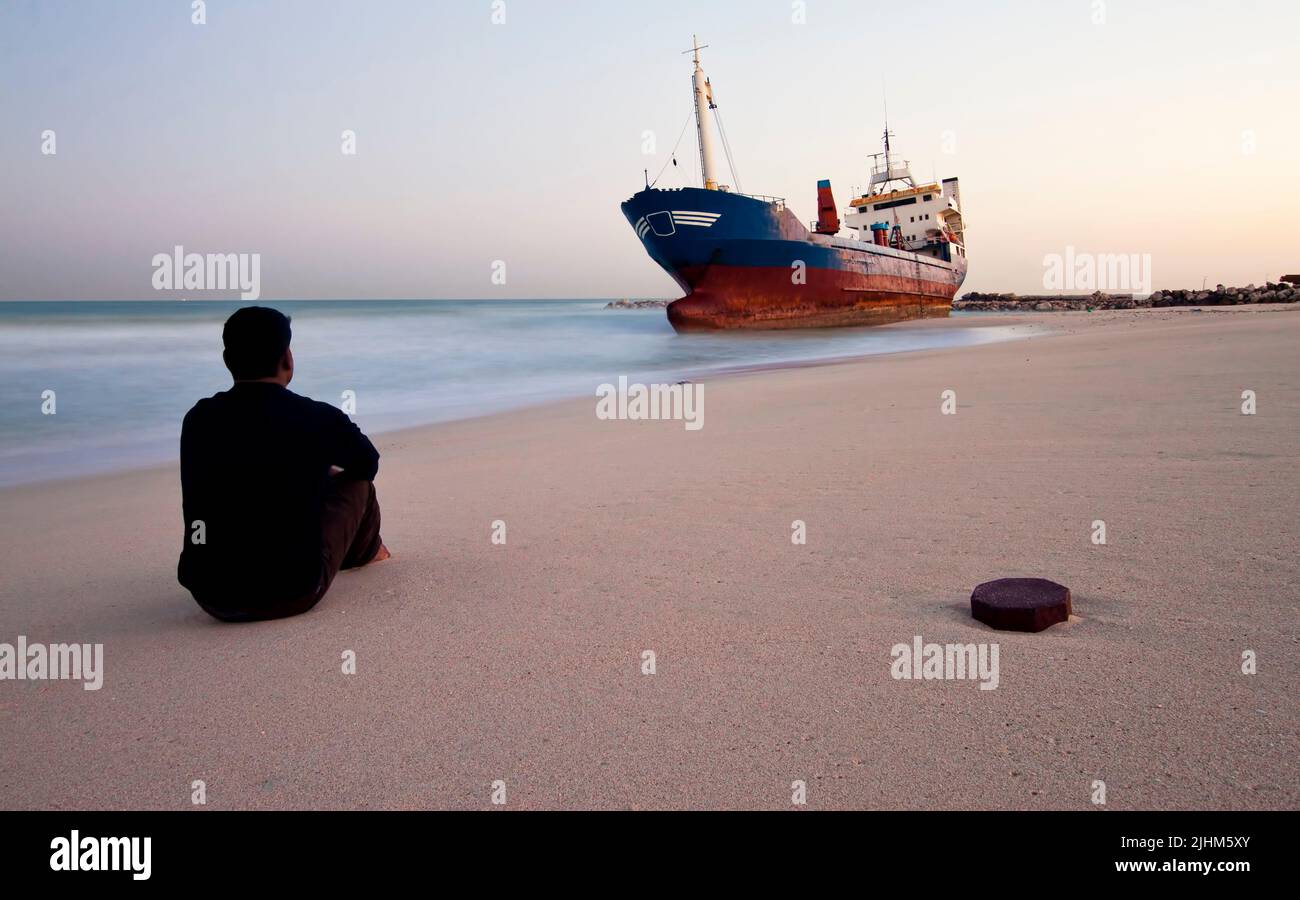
[623, 39, 966, 332]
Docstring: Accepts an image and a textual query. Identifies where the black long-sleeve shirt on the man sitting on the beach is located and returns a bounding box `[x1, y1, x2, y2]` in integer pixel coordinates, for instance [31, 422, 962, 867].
[177, 381, 380, 609]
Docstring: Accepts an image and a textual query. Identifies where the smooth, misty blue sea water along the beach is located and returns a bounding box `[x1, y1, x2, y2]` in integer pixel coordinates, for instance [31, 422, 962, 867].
[0, 300, 1014, 485]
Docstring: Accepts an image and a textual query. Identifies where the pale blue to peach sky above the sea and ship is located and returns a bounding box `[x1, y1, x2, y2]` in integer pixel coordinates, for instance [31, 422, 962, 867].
[0, 0, 1300, 299]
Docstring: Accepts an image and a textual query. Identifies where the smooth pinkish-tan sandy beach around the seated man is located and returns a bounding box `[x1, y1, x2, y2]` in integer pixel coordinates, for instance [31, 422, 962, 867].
[0, 307, 1300, 809]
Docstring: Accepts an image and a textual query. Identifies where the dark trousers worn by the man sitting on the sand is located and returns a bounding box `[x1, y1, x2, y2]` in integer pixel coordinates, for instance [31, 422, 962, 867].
[195, 479, 382, 622]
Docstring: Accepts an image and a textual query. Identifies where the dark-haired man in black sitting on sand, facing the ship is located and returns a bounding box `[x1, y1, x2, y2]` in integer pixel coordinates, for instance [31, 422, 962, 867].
[178, 307, 390, 622]
